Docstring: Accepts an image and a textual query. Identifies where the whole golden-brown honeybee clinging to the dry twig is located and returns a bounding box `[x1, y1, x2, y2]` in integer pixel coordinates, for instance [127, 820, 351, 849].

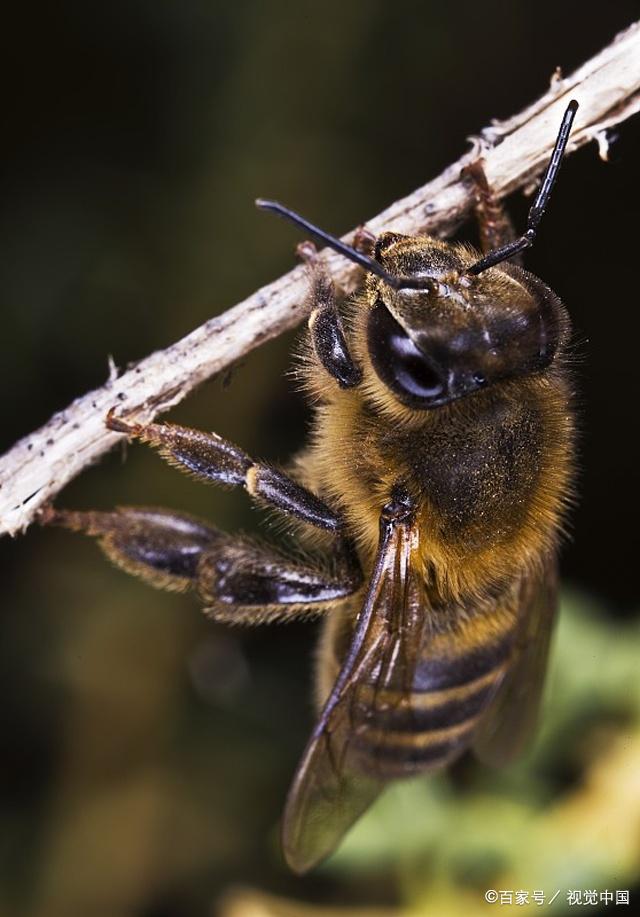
[45, 102, 577, 873]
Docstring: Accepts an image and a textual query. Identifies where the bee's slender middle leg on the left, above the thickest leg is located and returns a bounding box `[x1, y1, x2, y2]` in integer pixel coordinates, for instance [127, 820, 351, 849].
[107, 410, 344, 534]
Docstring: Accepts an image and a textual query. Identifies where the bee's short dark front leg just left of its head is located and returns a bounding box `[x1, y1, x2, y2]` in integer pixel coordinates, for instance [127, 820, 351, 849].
[298, 242, 362, 388]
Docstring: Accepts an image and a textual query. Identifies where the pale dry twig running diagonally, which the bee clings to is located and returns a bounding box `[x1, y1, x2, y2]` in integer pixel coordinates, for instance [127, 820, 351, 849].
[0, 23, 640, 535]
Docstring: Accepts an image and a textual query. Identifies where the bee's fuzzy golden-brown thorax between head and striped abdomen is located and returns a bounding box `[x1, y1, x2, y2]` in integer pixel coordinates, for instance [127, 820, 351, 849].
[304, 362, 573, 604]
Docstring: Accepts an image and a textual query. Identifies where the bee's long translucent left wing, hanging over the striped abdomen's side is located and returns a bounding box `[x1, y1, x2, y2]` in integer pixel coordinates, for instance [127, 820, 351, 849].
[282, 508, 422, 873]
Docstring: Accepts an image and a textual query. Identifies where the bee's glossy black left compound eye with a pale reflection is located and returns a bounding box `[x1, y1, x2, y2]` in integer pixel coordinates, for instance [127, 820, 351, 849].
[367, 300, 447, 410]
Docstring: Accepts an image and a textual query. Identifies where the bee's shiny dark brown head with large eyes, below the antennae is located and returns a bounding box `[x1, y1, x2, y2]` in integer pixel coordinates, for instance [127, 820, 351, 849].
[366, 233, 568, 410]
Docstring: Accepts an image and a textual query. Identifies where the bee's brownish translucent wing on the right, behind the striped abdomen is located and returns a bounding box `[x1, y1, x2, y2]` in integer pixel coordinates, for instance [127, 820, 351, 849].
[473, 558, 558, 767]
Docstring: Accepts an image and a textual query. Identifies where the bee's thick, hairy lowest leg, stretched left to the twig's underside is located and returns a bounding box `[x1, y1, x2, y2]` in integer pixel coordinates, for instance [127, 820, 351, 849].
[41, 506, 362, 624]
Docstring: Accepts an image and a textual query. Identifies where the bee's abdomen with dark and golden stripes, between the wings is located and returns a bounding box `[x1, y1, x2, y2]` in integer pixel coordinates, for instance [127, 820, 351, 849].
[353, 613, 515, 779]
